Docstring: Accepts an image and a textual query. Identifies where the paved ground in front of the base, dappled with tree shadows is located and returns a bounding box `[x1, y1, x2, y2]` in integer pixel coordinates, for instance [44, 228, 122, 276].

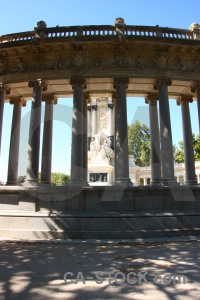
[0, 238, 200, 300]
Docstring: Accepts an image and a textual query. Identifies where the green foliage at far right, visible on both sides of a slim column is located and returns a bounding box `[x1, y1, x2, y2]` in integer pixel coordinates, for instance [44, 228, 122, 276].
[174, 134, 200, 163]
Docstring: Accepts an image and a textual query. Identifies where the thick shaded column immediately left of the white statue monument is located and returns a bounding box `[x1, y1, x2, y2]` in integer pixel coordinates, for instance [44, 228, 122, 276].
[69, 78, 87, 187]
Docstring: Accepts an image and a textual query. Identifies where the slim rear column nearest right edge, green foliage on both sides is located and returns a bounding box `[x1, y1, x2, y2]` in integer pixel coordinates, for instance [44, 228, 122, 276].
[177, 95, 197, 185]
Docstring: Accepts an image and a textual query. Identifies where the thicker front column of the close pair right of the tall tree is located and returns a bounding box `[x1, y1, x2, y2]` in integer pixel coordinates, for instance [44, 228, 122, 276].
[154, 78, 176, 186]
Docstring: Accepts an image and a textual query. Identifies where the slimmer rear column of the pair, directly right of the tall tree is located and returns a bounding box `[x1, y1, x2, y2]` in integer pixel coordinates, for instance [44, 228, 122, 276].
[145, 93, 161, 185]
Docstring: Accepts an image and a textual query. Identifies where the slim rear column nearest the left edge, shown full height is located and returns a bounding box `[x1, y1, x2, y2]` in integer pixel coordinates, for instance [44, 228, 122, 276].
[6, 97, 26, 185]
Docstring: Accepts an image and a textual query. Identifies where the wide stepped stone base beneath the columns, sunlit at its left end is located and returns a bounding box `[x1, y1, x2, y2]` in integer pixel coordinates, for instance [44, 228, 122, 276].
[0, 186, 200, 240]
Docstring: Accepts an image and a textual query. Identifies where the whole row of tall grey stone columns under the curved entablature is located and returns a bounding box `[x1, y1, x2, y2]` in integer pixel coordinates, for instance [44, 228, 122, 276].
[0, 77, 200, 187]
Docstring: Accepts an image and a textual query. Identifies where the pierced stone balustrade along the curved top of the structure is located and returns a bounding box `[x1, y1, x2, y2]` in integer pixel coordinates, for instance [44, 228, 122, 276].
[0, 25, 196, 43]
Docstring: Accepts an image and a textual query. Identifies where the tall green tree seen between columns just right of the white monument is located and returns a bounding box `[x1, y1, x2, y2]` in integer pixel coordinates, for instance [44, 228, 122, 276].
[128, 121, 150, 167]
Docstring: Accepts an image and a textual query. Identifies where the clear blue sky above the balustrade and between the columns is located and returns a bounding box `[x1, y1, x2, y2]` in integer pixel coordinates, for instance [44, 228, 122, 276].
[0, 0, 200, 181]
